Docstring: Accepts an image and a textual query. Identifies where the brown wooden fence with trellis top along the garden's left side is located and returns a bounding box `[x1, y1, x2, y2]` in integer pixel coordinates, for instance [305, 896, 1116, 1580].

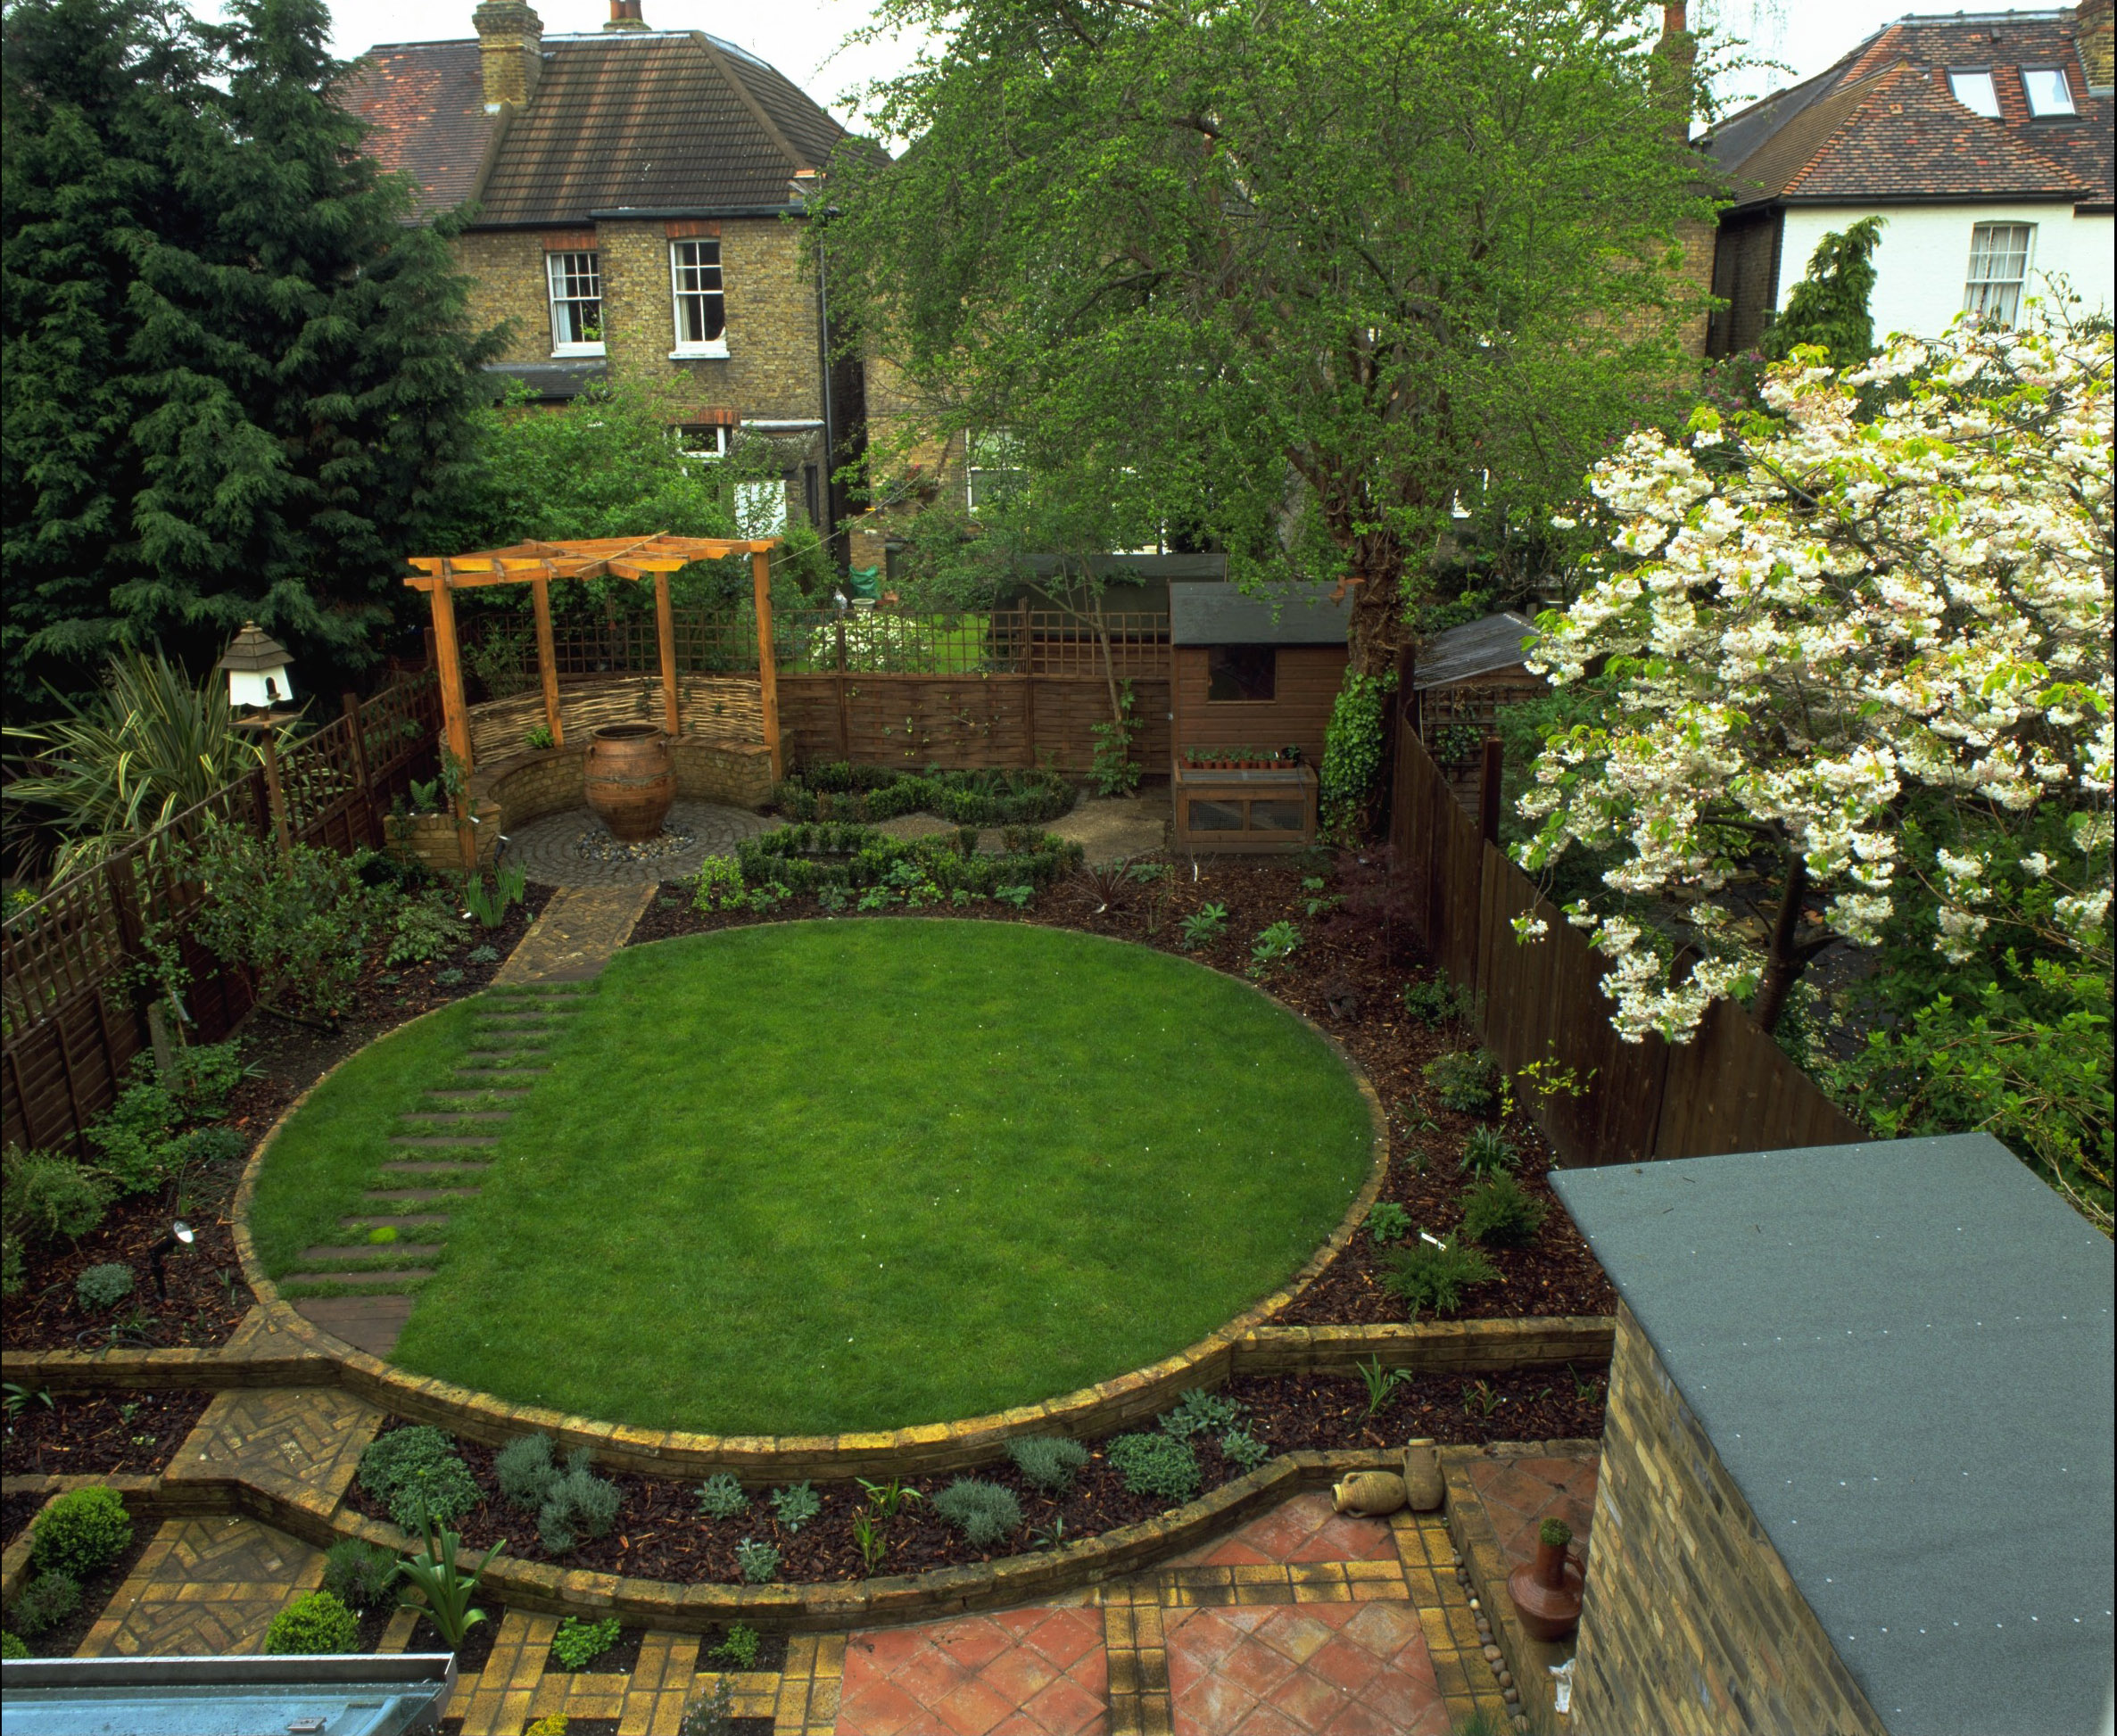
[0, 674, 441, 1156]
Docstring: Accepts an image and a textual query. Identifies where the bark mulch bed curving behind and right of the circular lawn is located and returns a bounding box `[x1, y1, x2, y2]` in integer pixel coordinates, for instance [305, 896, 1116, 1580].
[629, 851, 1617, 1326]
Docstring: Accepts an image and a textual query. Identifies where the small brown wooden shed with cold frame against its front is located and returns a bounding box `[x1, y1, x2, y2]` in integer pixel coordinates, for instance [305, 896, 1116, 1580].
[1169, 584, 1352, 853]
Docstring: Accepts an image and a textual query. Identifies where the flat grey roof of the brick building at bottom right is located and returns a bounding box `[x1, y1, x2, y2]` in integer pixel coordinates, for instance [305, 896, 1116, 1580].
[1551, 1133, 2117, 1736]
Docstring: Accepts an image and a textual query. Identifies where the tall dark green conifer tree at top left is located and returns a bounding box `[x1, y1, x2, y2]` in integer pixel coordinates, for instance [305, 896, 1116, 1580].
[0, 0, 492, 709]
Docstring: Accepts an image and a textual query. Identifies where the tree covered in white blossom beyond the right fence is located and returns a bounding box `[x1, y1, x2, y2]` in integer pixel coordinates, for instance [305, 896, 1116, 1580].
[1517, 322, 2113, 1042]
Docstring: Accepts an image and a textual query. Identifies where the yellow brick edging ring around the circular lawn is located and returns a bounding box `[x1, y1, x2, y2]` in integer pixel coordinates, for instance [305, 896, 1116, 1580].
[211, 936, 1422, 1482]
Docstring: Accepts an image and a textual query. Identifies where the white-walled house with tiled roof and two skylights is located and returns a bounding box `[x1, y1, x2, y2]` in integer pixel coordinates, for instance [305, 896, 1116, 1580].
[1700, 0, 2117, 356]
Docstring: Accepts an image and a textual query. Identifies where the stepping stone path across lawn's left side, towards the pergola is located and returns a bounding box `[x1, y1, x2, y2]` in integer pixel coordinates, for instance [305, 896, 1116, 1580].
[279, 887, 654, 1357]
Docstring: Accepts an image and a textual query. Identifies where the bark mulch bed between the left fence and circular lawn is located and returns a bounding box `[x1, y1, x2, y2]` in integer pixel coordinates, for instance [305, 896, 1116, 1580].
[0, 887, 550, 1351]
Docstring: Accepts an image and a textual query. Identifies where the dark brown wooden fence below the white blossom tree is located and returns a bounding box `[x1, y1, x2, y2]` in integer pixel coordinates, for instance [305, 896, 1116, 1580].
[1391, 690, 1865, 1164]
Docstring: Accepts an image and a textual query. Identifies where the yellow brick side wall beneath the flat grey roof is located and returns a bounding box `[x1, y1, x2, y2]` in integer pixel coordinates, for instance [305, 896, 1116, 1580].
[1571, 1309, 1886, 1736]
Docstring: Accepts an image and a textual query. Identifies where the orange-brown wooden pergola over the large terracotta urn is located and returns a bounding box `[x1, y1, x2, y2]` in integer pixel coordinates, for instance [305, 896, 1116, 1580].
[404, 533, 783, 774]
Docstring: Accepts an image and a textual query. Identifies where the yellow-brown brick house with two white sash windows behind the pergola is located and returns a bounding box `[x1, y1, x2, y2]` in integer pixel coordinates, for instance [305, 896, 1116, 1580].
[341, 0, 866, 554]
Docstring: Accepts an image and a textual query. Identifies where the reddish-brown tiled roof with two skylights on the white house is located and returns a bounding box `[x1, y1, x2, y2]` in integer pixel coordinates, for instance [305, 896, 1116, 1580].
[1702, 11, 2113, 205]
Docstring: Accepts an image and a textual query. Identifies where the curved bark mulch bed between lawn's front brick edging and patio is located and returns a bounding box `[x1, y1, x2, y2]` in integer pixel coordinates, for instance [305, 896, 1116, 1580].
[345, 1369, 1605, 1591]
